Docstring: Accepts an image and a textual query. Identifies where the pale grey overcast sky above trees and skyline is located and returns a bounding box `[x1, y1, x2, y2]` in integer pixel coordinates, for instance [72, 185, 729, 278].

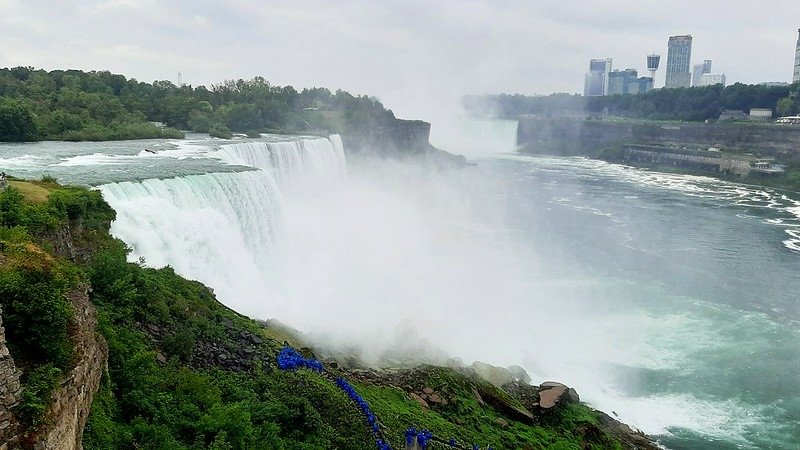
[0, 0, 800, 120]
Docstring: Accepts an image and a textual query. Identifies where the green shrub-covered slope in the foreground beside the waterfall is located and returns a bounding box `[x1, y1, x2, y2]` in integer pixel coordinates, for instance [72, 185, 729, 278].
[0, 182, 636, 449]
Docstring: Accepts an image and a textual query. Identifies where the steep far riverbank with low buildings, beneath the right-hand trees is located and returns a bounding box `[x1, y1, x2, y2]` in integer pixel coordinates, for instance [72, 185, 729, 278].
[517, 118, 800, 193]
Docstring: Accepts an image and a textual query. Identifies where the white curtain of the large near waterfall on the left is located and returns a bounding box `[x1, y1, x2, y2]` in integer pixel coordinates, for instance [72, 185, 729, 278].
[100, 135, 346, 312]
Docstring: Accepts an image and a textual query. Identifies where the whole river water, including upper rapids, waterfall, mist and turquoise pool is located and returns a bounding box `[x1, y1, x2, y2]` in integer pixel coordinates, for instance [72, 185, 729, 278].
[0, 136, 800, 449]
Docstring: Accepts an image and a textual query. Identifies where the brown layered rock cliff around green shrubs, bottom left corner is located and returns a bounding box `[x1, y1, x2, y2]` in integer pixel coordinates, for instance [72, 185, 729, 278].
[0, 286, 108, 450]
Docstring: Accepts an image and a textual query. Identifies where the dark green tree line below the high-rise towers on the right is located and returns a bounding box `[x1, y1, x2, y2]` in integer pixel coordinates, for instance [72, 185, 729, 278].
[462, 83, 800, 122]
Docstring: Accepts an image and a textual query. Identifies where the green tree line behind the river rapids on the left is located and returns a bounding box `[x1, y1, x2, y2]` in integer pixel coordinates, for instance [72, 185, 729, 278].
[0, 67, 394, 142]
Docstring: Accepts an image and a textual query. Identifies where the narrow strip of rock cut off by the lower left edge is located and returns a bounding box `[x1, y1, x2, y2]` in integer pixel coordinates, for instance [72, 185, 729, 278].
[0, 310, 22, 450]
